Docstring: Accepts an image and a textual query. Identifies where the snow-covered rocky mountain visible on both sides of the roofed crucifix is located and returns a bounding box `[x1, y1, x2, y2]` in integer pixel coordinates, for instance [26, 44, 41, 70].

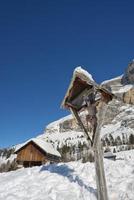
[35, 61, 134, 160]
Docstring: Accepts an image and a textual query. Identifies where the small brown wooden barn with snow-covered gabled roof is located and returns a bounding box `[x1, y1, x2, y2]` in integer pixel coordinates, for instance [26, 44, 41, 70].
[15, 138, 61, 167]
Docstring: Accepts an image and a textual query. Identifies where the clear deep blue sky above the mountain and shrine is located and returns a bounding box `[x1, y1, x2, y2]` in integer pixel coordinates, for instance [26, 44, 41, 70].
[0, 0, 134, 147]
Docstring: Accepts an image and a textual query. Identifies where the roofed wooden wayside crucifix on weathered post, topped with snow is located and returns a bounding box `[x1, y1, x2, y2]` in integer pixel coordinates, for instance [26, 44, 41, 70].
[62, 67, 113, 200]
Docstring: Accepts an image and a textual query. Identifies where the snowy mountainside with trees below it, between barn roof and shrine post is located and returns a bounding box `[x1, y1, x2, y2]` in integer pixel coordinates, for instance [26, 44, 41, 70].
[38, 115, 92, 161]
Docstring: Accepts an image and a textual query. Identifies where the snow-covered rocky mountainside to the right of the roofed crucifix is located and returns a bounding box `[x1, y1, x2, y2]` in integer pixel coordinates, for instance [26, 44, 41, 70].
[101, 61, 134, 145]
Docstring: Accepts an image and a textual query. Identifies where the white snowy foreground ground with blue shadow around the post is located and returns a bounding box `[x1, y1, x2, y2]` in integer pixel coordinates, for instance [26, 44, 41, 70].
[0, 150, 134, 200]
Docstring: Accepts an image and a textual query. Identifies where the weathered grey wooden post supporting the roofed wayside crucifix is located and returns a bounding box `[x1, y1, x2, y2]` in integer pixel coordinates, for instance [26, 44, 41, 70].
[93, 101, 108, 200]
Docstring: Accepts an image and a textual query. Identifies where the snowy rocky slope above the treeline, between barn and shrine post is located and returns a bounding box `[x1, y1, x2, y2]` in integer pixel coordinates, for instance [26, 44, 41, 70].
[38, 115, 87, 148]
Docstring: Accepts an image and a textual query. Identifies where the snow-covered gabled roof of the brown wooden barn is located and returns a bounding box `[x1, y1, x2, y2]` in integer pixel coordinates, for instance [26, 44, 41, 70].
[15, 138, 61, 157]
